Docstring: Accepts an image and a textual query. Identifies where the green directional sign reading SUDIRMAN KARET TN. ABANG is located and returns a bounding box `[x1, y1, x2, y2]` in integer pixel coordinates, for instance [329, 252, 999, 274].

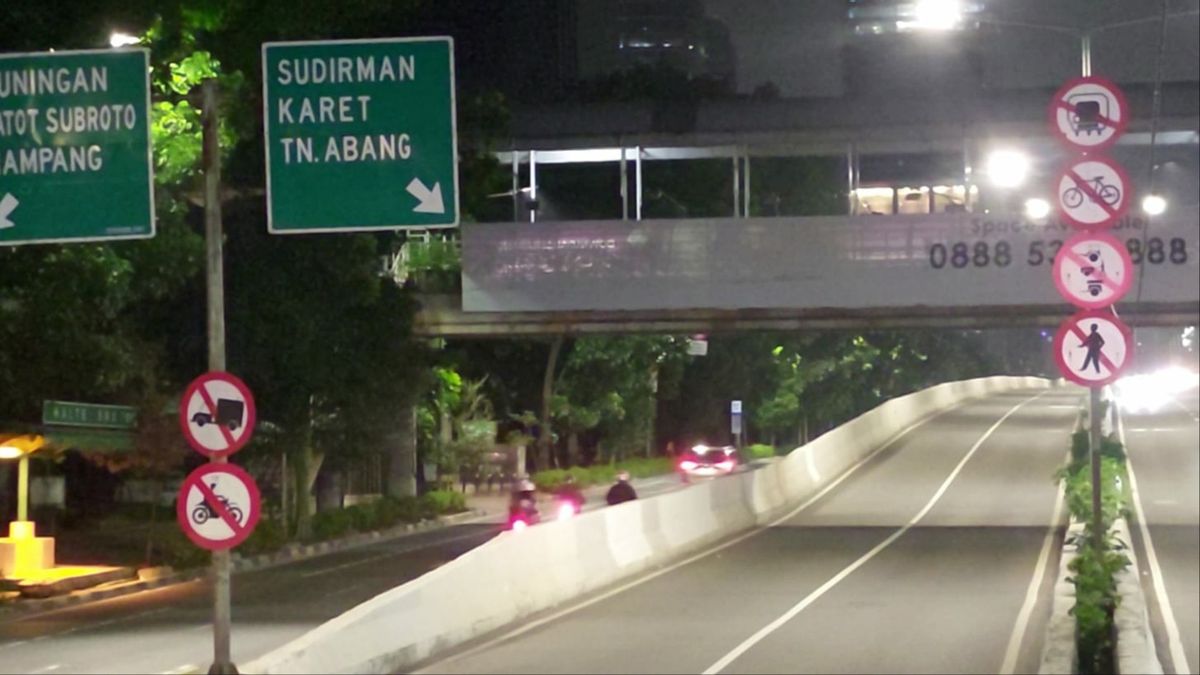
[263, 37, 458, 234]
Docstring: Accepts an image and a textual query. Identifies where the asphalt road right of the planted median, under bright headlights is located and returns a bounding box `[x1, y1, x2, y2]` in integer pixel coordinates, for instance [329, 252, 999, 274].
[1122, 388, 1200, 673]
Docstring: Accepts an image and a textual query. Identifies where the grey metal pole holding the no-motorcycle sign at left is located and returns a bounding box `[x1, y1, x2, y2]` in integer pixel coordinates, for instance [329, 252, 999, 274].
[200, 78, 238, 675]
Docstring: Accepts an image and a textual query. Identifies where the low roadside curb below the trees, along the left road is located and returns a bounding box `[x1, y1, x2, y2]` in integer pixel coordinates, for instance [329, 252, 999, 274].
[0, 509, 488, 622]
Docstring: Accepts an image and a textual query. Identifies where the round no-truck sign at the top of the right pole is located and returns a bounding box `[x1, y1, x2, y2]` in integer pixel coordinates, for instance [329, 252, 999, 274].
[1050, 77, 1129, 153]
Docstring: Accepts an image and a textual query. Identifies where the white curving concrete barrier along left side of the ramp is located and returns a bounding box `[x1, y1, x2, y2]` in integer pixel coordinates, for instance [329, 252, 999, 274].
[242, 377, 1051, 673]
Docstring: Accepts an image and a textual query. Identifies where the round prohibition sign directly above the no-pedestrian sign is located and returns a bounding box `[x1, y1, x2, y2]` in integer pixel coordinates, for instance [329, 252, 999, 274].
[1054, 232, 1133, 310]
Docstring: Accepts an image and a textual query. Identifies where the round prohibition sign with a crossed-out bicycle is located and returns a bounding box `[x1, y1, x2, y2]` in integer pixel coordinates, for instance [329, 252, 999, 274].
[1055, 157, 1133, 228]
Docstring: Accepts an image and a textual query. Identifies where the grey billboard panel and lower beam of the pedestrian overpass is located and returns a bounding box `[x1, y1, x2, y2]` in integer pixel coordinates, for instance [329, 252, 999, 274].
[415, 207, 1200, 338]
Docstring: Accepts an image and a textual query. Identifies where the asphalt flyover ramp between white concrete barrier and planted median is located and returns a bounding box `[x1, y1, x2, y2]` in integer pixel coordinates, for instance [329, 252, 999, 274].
[419, 389, 1081, 673]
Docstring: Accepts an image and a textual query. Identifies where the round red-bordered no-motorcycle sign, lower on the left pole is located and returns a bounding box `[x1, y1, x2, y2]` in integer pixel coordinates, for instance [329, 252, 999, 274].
[175, 462, 262, 551]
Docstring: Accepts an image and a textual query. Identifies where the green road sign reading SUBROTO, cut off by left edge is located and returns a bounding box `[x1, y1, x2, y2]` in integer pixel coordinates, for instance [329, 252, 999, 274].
[0, 49, 154, 246]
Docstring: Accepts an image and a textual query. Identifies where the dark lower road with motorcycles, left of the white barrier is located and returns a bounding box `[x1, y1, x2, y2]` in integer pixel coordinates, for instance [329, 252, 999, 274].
[0, 476, 682, 674]
